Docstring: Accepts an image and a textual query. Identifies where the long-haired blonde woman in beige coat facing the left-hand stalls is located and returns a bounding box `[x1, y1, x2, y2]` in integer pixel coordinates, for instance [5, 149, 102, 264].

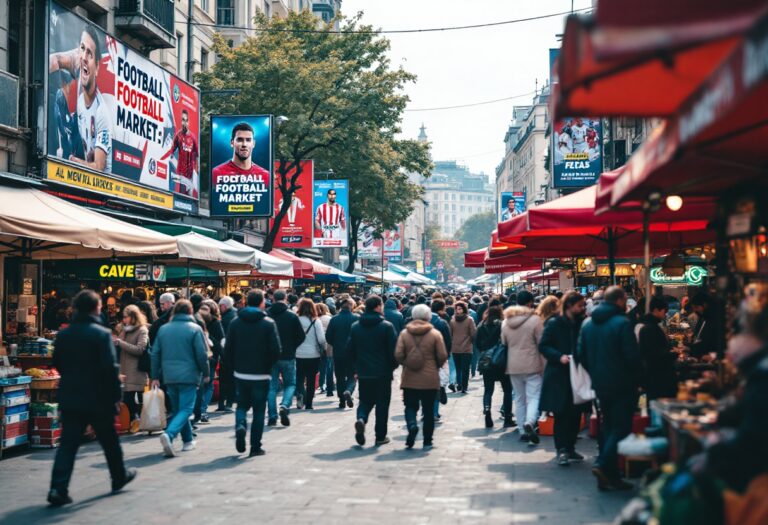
[115, 304, 149, 433]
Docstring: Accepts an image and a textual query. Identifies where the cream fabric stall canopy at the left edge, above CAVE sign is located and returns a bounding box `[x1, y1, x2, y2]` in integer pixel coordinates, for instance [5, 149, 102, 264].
[0, 186, 178, 259]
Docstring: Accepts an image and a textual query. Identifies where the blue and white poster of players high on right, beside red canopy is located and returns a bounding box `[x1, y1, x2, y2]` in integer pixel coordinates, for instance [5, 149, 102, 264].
[552, 117, 603, 188]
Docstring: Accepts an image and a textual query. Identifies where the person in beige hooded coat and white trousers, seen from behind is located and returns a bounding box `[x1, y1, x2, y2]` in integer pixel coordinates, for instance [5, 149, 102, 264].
[501, 291, 545, 445]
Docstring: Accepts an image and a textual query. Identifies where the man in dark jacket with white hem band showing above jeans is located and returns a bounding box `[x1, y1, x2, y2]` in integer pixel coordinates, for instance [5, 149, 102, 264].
[224, 291, 280, 457]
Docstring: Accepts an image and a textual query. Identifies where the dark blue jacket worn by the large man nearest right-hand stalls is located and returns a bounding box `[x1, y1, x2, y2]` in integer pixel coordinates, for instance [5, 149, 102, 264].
[576, 302, 643, 397]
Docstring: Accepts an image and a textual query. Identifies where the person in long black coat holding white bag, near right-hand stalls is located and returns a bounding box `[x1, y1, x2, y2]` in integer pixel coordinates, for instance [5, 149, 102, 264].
[539, 290, 588, 467]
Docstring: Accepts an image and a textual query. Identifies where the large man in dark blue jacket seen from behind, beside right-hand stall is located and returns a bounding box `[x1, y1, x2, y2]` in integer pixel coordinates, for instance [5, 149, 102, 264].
[576, 286, 643, 490]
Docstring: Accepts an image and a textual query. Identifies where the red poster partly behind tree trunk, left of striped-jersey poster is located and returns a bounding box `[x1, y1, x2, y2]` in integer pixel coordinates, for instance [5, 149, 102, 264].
[269, 160, 315, 248]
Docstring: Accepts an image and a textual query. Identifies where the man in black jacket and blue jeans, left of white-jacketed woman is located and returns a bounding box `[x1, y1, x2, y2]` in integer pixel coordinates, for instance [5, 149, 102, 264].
[267, 290, 307, 427]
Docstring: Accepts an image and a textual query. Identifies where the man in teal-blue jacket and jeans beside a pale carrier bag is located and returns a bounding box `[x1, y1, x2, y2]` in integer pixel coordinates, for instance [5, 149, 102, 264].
[152, 299, 211, 457]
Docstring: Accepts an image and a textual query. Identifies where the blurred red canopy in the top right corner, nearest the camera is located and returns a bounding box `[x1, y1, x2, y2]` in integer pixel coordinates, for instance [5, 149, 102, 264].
[551, 0, 767, 120]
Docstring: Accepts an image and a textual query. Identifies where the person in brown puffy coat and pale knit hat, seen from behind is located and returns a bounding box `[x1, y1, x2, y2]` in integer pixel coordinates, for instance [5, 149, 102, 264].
[395, 304, 448, 448]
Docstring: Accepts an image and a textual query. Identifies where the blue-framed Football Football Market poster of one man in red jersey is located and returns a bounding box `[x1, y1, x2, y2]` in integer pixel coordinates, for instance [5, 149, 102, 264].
[211, 115, 273, 217]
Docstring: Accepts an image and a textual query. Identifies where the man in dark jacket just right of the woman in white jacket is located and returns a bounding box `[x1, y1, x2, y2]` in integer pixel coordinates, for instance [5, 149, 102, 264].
[325, 296, 360, 409]
